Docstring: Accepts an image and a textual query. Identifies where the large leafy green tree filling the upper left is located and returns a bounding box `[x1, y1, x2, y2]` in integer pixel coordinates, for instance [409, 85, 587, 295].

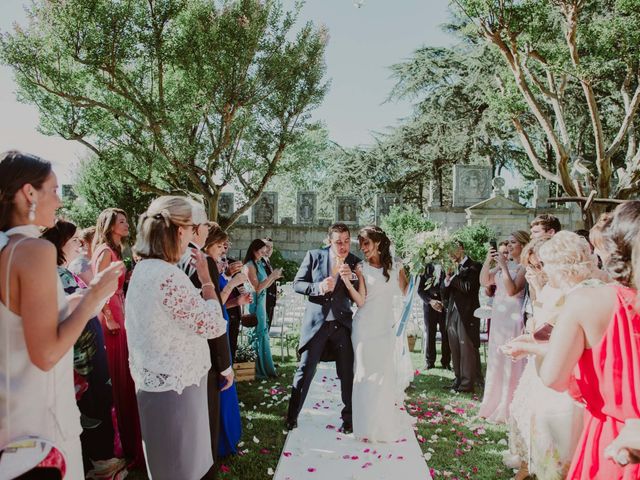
[0, 0, 327, 225]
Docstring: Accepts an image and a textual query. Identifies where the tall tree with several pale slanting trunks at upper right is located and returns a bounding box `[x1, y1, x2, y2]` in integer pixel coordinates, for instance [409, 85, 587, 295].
[456, 0, 640, 213]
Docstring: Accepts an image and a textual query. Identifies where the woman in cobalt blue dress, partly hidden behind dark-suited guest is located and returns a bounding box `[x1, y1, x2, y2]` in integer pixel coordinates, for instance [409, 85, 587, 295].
[204, 229, 251, 457]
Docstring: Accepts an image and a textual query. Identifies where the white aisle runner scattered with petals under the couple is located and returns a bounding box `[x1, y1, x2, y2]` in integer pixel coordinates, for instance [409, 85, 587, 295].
[274, 363, 431, 480]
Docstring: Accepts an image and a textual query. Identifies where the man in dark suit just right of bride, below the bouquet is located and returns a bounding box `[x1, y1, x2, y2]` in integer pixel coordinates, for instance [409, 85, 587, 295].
[418, 263, 451, 369]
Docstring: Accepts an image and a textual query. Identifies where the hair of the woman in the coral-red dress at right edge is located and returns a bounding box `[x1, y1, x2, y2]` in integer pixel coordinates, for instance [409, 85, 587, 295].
[603, 200, 640, 287]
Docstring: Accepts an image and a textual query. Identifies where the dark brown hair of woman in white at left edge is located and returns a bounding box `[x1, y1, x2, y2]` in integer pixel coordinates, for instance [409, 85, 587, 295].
[0, 150, 52, 231]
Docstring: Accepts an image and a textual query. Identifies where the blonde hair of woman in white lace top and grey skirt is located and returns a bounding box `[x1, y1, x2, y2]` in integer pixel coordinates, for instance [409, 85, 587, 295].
[133, 196, 192, 263]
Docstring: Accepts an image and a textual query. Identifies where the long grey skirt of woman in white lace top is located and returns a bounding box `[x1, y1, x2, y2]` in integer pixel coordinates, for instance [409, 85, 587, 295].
[136, 375, 213, 480]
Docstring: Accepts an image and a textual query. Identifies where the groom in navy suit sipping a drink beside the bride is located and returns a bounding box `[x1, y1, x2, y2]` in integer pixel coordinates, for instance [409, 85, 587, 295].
[287, 223, 360, 433]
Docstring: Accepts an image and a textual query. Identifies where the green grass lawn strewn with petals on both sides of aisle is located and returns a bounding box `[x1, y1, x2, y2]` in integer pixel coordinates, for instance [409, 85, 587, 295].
[129, 353, 513, 480]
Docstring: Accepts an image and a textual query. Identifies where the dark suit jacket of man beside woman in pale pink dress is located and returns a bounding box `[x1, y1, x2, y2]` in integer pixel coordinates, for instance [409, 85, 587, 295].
[442, 257, 482, 347]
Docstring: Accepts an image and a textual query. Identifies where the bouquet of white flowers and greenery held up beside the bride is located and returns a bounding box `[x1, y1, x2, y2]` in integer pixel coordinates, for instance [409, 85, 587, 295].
[405, 229, 456, 288]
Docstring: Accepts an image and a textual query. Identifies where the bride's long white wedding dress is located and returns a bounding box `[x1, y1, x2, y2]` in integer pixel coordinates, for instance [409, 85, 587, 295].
[351, 262, 411, 442]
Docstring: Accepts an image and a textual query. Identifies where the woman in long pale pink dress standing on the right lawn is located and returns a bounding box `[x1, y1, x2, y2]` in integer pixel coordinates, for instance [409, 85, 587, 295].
[478, 230, 529, 423]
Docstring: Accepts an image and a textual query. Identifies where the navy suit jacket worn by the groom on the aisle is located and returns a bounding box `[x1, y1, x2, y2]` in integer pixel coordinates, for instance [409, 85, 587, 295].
[293, 247, 360, 353]
